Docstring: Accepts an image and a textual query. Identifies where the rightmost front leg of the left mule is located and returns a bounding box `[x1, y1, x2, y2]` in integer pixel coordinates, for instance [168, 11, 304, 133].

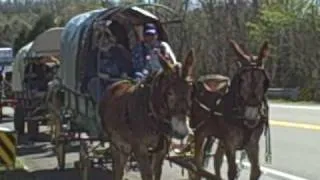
[152, 140, 169, 180]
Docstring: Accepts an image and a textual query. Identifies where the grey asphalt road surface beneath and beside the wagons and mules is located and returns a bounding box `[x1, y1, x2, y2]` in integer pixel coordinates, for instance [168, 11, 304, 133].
[0, 104, 320, 180]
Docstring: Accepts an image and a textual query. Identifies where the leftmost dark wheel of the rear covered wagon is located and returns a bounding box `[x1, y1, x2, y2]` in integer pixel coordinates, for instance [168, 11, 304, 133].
[13, 103, 25, 135]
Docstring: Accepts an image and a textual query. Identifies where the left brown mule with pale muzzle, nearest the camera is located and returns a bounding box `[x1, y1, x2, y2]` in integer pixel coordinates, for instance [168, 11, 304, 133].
[99, 51, 194, 180]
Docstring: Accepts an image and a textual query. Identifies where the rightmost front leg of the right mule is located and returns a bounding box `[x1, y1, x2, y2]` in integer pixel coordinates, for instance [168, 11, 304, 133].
[246, 142, 261, 180]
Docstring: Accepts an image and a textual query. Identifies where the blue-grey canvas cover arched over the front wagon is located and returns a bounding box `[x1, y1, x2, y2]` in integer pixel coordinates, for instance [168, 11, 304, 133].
[60, 6, 167, 91]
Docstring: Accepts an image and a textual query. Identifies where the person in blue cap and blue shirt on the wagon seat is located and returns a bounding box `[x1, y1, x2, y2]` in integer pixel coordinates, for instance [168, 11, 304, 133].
[132, 23, 174, 80]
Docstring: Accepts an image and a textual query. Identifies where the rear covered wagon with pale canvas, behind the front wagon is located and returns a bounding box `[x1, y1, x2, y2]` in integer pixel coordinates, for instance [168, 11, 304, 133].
[12, 27, 63, 138]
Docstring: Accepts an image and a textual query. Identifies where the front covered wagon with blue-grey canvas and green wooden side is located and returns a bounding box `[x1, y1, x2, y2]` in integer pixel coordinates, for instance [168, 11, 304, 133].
[56, 4, 184, 176]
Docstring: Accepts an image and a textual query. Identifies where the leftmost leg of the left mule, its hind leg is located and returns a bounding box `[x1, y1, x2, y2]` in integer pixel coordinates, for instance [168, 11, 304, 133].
[111, 146, 129, 180]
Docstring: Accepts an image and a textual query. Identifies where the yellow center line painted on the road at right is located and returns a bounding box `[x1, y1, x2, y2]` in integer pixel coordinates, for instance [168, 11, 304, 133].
[270, 120, 320, 131]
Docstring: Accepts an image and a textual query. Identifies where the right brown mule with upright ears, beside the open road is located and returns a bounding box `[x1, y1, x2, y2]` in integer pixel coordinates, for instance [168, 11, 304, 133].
[190, 40, 269, 180]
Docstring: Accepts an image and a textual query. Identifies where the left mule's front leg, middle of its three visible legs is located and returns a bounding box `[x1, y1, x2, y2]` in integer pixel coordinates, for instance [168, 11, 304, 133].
[134, 148, 153, 180]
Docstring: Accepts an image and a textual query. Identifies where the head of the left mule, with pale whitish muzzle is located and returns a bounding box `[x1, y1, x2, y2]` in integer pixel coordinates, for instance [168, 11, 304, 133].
[158, 50, 195, 139]
